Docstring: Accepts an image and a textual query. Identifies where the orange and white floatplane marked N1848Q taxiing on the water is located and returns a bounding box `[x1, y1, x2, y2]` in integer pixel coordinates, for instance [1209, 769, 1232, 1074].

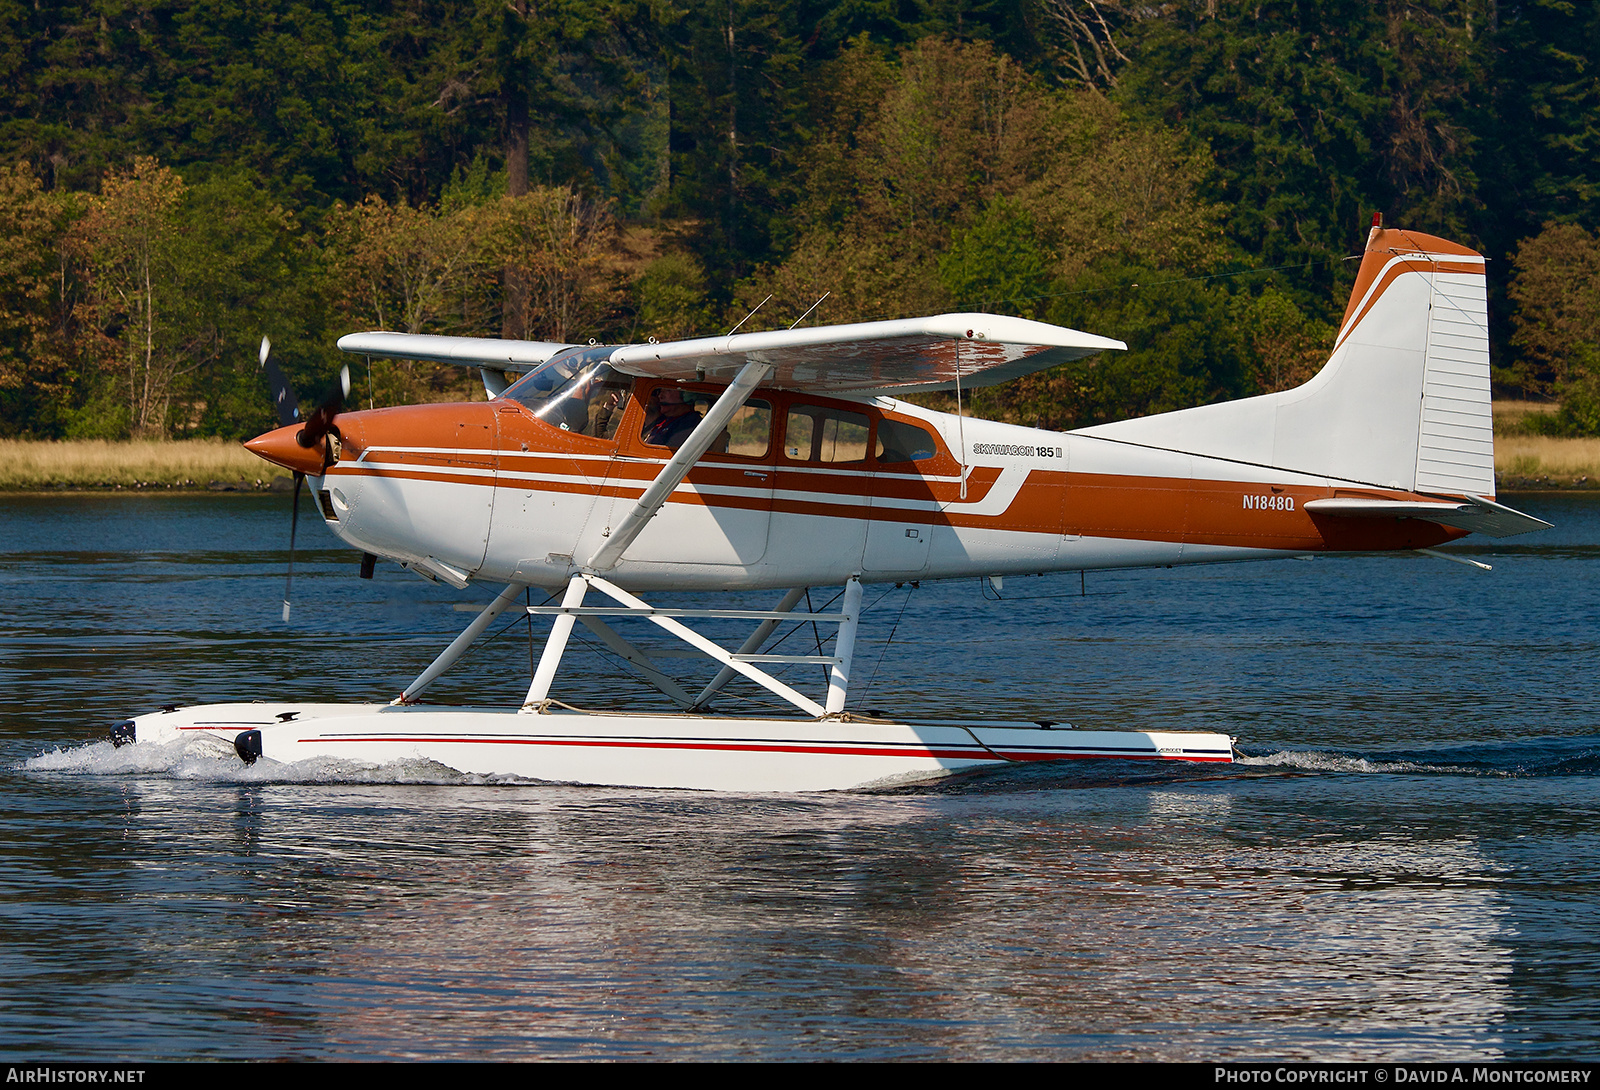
[112, 221, 1547, 791]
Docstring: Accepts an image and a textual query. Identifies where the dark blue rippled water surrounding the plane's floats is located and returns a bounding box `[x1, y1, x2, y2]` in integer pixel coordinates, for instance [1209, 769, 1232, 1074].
[0, 496, 1600, 1060]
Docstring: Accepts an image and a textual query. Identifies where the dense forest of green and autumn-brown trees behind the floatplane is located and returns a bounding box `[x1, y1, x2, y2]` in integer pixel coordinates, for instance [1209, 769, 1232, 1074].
[0, 0, 1600, 439]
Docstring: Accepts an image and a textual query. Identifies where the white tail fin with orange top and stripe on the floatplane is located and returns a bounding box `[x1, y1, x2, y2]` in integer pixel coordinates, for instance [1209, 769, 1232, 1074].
[1082, 227, 1494, 496]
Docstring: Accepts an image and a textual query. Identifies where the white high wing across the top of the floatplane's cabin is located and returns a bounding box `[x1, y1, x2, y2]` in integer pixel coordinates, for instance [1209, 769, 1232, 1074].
[339, 314, 1128, 397]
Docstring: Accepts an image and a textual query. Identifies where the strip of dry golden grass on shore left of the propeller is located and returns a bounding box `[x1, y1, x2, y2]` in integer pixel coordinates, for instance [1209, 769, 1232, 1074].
[0, 439, 290, 491]
